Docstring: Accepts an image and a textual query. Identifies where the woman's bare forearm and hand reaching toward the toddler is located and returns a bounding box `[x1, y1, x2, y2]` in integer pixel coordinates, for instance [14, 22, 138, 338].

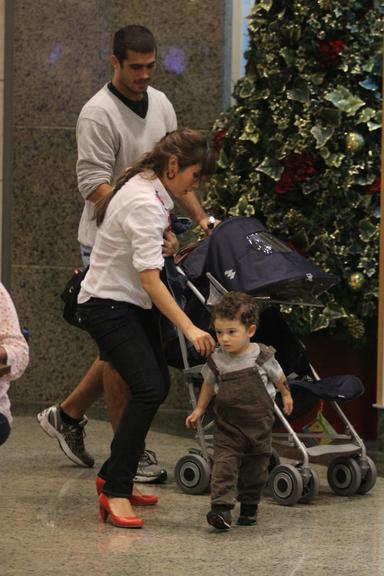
[140, 269, 215, 356]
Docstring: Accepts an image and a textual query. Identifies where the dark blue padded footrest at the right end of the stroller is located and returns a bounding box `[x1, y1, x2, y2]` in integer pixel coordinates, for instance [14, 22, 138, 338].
[290, 374, 364, 401]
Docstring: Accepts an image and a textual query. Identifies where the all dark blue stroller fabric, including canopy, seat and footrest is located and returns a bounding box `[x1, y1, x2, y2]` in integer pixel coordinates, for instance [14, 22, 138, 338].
[168, 216, 364, 402]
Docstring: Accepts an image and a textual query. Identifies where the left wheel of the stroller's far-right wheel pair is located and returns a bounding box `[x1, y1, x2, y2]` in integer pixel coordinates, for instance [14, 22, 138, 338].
[327, 456, 362, 496]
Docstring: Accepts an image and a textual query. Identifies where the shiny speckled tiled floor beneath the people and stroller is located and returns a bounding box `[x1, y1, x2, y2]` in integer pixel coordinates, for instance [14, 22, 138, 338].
[0, 416, 384, 576]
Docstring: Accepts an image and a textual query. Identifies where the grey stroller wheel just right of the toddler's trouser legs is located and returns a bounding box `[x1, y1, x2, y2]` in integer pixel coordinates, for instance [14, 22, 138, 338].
[269, 464, 303, 506]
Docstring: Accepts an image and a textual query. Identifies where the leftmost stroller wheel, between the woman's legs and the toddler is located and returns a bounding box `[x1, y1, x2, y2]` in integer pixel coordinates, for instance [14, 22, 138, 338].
[175, 453, 211, 494]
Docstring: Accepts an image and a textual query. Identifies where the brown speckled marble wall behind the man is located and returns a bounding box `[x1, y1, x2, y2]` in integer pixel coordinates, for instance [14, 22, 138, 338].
[7, 0, 230, 409]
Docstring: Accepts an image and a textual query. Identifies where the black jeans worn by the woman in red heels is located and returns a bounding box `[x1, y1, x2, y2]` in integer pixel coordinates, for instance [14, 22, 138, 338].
[78, 298, 170, 498]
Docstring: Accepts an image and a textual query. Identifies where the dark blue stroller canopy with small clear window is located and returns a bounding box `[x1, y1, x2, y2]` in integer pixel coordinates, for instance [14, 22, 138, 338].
[182, 216, 338, 305]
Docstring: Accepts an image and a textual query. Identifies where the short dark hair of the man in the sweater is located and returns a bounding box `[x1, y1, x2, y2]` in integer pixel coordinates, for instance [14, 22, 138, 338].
[113, 24, 157, 64]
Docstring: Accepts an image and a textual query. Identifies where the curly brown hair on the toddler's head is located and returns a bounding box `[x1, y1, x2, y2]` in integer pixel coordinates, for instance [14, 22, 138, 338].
[211, 292, 260, 328]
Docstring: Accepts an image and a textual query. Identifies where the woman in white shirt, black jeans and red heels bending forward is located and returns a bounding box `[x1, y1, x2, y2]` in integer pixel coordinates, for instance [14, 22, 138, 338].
[78, 129, 215, 528]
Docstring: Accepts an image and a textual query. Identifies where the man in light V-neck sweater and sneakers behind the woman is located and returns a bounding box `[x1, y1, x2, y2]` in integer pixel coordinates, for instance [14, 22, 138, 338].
[37, 25, 209, 482]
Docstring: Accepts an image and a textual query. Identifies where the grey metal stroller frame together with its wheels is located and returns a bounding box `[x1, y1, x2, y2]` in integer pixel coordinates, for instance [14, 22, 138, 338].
[175, 266, 377, 506]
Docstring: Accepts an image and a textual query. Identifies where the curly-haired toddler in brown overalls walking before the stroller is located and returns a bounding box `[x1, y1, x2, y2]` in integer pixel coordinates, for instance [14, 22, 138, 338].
[186, 292, 293, 530]
